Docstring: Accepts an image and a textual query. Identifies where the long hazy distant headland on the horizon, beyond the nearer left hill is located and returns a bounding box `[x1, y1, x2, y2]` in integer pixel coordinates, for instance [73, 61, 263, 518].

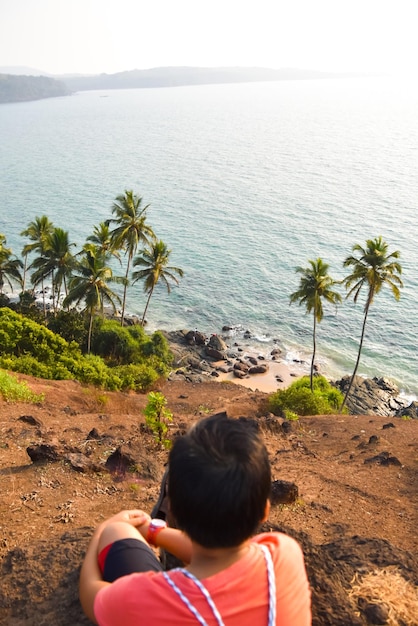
[63, 67, 342, 91]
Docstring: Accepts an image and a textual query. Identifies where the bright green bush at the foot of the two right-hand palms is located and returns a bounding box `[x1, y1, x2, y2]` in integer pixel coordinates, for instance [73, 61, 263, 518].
[269, 376, 343, 417]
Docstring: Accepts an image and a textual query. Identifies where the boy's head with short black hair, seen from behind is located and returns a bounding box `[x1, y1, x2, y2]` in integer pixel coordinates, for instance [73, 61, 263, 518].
[168, 414, 271, 548]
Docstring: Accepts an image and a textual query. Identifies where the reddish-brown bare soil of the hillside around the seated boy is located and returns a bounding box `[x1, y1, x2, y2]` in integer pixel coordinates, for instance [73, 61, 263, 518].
[0, 376, 418, 626]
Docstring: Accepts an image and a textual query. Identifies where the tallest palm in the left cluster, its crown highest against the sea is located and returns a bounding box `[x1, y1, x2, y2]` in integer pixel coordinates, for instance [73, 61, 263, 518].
[111, 191, 155, 326]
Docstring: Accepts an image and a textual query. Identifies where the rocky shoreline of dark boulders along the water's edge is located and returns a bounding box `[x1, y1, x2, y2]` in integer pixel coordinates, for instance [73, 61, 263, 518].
[163, 327, 418, 419]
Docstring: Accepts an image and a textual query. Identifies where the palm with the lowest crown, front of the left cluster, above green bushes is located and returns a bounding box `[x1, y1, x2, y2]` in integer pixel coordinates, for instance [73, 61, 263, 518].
[63, 247, 126, 354]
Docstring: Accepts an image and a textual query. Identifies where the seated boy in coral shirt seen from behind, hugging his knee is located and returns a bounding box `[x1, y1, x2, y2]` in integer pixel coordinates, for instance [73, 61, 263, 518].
[80, 414, 311, 626]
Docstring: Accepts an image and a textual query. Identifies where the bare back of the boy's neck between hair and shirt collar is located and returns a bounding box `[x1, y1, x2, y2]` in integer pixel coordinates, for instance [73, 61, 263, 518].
[186, 541, 250, 580]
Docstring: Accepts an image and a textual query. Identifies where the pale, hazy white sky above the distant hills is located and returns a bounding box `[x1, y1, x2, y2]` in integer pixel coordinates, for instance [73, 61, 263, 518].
[0, 0, 418, 74]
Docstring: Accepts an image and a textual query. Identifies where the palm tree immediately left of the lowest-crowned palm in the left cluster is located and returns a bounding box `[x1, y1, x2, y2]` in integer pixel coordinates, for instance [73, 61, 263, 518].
[31, 228, 75, 313]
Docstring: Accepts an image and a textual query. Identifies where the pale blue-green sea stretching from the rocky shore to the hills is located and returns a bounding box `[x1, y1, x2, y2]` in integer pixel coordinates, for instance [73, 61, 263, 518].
[0, 77, 418, 398]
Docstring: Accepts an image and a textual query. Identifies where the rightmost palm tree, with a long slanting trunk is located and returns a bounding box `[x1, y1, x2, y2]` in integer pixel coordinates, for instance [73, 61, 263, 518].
[340, 236, 403, 411]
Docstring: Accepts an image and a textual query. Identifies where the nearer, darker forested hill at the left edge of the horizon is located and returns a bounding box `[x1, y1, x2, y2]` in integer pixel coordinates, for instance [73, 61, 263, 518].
[0, 74, 70, 103]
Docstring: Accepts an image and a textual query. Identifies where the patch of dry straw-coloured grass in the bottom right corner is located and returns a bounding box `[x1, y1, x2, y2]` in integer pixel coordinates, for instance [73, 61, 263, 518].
[349, 567, 418, 626]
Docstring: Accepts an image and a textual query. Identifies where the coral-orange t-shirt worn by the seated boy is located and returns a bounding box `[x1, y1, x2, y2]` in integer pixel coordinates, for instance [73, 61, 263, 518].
[94, 533, 311, 626]
